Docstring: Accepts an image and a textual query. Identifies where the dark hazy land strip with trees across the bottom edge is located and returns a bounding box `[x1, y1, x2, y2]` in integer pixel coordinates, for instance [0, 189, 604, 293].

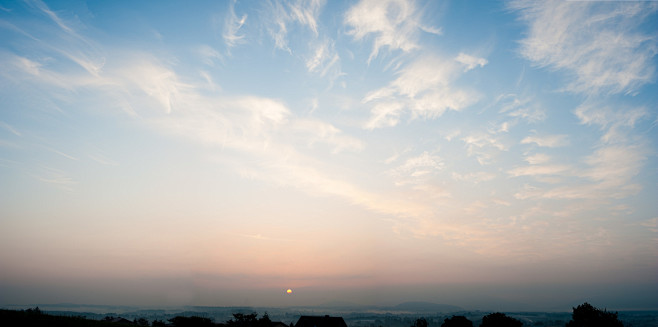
[0, 303, 658, 327]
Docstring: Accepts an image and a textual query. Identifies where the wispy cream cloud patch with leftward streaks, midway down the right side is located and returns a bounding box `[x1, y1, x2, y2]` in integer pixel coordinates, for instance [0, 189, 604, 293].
[509, 101, 649, 201]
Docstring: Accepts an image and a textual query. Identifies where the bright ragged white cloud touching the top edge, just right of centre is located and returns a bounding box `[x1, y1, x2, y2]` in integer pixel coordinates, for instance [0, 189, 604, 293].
[345, 0, 440, 63]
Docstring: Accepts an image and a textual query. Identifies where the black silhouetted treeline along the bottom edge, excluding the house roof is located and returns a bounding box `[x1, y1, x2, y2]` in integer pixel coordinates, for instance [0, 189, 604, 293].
[0, 303, 624, 327]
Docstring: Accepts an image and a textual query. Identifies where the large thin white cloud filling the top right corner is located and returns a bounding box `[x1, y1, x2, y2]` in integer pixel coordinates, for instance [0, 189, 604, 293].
[511, 1, 658, 93]
